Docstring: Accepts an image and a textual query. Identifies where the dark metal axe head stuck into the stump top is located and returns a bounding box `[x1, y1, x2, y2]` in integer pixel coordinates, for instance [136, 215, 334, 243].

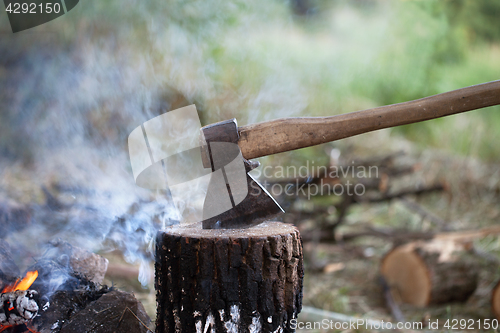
[200, 119, 284, 229]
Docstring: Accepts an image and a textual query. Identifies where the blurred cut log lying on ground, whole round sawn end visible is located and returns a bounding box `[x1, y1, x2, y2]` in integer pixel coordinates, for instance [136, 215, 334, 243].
[381, 239, 478, 307]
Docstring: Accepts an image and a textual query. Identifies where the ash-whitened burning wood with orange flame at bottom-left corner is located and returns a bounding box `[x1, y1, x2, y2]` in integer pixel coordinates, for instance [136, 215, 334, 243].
[0, 271, 38, 332]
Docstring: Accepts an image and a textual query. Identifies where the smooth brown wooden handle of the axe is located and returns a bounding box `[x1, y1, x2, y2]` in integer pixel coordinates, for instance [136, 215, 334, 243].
[238, 80, 500, 159]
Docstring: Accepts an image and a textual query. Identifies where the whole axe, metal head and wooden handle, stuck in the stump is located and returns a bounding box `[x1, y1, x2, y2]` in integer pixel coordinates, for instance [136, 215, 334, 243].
[201, 80, 500, 229]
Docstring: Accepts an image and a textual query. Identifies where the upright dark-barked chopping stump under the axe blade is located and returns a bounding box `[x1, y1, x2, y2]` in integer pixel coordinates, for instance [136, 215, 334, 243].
[155, 222, 304, 333]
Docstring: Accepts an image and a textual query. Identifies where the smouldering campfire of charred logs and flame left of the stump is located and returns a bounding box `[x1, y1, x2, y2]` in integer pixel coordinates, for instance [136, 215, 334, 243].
[0, 235, 150, 333]
